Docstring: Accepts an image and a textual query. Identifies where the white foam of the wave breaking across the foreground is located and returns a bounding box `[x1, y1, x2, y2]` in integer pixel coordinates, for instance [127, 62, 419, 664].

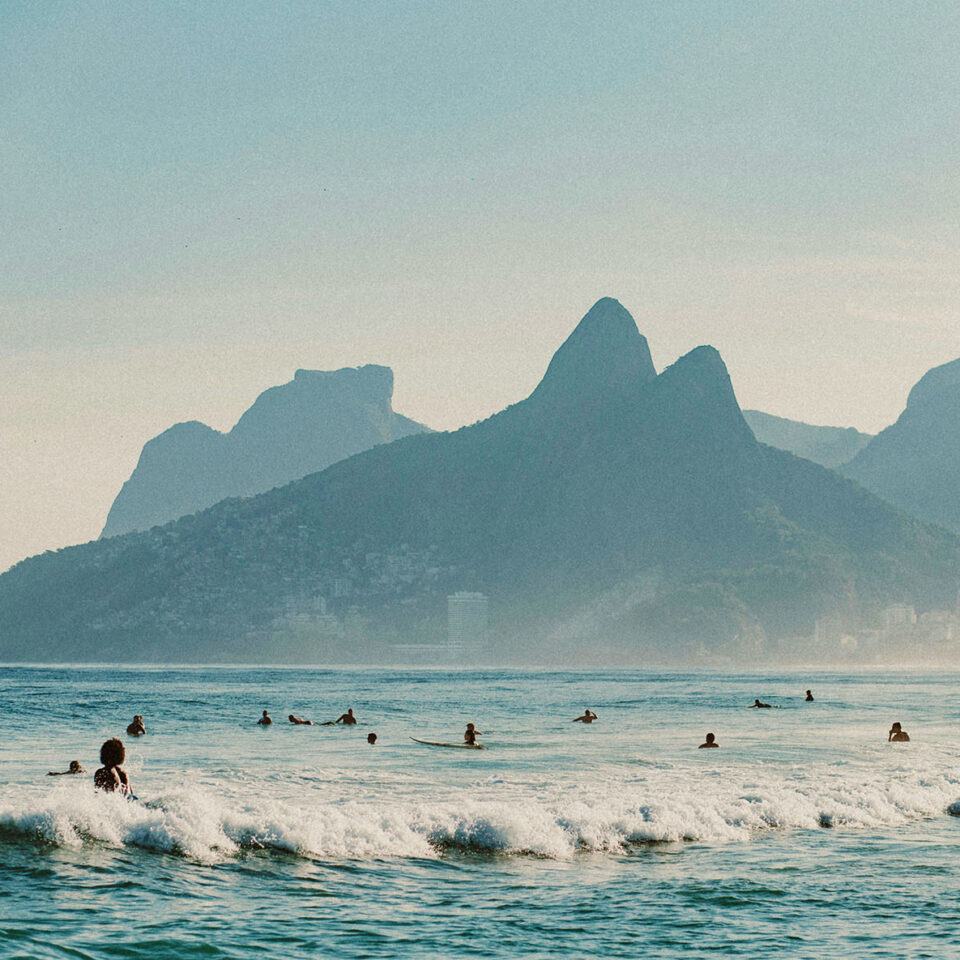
[0, 765, 960, 862]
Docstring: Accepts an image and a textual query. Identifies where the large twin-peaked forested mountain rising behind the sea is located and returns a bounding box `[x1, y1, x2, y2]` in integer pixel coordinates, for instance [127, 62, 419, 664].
[0, 299, 960, 663]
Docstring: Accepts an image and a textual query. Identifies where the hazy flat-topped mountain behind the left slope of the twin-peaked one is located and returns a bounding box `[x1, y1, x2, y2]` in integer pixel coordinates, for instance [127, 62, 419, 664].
[101, 364, 427, 537]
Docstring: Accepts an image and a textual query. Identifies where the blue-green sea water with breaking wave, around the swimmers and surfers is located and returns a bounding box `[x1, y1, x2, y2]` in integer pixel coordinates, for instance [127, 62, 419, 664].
[0, 666, 960, 960]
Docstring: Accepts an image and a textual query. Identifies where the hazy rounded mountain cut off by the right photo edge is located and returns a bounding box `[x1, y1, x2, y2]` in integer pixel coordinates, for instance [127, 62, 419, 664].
[841, 360, 960, 530]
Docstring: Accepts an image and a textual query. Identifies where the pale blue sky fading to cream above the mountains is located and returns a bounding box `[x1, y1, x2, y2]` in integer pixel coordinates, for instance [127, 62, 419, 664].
[0, 0, 960, 570]
